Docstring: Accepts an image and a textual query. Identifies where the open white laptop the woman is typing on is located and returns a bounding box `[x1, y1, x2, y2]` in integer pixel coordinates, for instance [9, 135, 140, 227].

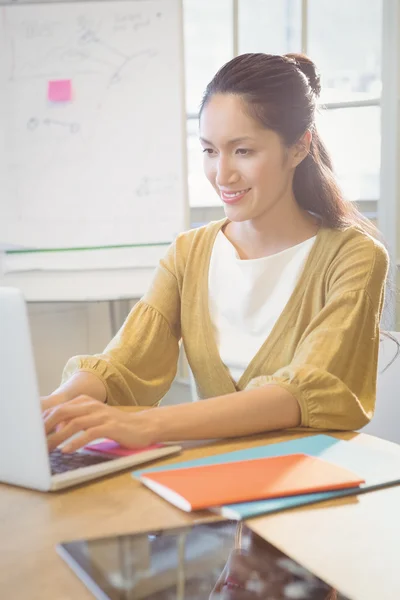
[0, 287, 181, 492]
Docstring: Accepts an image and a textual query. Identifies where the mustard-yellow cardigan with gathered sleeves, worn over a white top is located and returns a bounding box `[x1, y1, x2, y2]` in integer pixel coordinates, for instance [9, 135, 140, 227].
[63, 219, 388, 429]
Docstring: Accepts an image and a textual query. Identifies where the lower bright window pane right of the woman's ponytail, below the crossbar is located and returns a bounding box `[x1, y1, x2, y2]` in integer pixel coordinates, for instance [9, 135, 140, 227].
[317, 106, 381, 201]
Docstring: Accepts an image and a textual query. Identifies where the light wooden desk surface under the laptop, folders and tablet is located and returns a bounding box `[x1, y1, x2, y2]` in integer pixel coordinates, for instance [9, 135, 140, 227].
[0, 433, 400, 600]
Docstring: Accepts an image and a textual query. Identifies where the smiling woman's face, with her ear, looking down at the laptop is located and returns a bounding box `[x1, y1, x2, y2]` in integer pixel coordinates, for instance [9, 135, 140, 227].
[200, 94, 303, 221]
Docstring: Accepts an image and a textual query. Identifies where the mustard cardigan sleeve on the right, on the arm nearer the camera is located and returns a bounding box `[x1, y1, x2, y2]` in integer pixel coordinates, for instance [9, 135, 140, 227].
[246, 237, 388, 430]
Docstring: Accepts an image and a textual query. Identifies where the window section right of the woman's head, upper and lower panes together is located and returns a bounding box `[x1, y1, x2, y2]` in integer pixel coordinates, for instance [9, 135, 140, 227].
[306, 0, 382, 200]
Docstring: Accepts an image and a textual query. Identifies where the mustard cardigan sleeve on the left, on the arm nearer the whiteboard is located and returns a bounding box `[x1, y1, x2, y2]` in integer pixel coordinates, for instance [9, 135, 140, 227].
[62, 240, 181, 406]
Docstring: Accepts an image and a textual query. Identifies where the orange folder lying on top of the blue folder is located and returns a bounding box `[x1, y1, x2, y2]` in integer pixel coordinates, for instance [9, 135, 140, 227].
[140, 454, 365, 512]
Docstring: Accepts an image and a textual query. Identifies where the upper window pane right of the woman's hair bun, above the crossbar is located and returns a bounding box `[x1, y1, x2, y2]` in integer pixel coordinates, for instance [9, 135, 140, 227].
[307, 0, 382, 103]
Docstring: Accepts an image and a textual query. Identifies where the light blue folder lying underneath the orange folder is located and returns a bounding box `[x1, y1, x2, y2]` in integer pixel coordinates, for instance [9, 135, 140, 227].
[132, 434, 400, 519]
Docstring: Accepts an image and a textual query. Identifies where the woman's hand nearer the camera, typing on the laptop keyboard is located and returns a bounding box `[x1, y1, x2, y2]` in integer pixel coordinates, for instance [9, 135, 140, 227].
[44, 396, 157, 452]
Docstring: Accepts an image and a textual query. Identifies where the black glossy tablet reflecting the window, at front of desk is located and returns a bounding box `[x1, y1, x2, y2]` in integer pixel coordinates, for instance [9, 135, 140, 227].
[57, 521, 345, 600]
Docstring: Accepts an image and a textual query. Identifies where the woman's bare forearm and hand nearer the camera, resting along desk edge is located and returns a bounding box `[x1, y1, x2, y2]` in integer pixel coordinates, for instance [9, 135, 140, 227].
[45, 385, 300, 452]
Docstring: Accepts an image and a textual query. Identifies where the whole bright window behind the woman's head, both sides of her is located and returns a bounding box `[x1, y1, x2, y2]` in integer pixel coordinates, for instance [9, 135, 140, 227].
[184, 0, 382, 212]
